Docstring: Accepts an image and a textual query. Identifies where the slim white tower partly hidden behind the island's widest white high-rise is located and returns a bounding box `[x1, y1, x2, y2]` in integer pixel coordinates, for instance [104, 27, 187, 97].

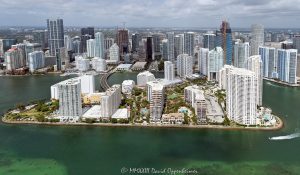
[246, 55, 263, 106]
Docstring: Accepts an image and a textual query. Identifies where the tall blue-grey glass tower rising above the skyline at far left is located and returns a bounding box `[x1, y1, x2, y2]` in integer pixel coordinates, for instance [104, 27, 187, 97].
[47, 19, 64, 56]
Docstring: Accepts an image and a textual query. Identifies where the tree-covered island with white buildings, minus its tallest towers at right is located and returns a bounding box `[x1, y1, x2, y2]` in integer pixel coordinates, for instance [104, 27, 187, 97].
[2, 62, 283, 130]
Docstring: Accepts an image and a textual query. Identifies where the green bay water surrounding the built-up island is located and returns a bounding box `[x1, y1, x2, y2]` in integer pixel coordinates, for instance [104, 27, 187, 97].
[0, 73, 300, 175]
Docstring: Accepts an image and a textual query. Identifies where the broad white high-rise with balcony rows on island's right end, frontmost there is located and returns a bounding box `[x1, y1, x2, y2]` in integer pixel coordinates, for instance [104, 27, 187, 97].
[219, 65, 258, 125]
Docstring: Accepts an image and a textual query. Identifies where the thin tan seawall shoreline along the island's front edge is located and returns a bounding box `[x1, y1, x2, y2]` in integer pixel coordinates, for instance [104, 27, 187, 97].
[1, 116, 284, 131]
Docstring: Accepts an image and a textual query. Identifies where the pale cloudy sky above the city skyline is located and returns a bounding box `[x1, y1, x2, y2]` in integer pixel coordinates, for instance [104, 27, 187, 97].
[0, 0, 300, 28]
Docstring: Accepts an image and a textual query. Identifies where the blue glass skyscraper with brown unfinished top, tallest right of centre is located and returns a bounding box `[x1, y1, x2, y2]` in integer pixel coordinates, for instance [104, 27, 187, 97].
[216, 21, 232, 65]
